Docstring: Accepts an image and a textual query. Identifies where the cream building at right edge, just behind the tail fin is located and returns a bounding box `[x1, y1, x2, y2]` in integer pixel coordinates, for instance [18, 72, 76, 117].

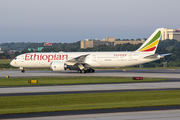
[162, 28, 180, 41]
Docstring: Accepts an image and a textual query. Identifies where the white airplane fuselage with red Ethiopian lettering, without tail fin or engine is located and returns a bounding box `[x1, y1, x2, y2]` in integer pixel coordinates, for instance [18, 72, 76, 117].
[10, 51, 160, 68]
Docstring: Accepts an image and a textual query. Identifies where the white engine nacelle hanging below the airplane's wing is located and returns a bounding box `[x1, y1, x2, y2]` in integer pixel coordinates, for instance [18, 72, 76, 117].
[50, 61, 67, 71]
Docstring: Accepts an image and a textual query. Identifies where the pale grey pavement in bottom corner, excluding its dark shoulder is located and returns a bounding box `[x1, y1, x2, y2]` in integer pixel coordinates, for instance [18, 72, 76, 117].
[20, 110, 180, 120]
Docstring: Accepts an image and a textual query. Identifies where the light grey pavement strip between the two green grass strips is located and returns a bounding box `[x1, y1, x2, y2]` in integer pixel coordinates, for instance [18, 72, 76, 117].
[0, 81, 180, 95]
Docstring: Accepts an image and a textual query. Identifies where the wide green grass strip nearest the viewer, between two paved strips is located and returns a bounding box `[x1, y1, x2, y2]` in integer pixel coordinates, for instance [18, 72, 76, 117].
[0, 90, 180, 114]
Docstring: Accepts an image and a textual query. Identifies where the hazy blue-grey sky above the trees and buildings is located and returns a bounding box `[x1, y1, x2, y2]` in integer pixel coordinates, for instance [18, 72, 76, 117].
[0, 0, 180, 43]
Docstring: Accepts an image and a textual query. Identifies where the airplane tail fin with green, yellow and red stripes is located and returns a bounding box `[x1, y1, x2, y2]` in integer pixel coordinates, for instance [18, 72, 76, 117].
[135, 28, 164, 54]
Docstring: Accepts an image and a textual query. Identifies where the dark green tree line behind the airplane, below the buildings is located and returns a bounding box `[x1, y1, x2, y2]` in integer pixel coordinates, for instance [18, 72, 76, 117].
[0, 40, 180, 67]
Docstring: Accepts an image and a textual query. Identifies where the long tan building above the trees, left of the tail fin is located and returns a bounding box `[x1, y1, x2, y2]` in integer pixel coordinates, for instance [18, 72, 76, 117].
[81, 37, 145, 49]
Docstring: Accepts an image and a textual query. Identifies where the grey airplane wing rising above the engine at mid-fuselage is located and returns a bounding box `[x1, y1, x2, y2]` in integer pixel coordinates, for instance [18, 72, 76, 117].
[65, 54, 89, 65]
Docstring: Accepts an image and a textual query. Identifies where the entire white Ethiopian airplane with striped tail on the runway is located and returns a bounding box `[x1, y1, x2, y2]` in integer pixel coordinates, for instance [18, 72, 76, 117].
[10, 28, 171, 73]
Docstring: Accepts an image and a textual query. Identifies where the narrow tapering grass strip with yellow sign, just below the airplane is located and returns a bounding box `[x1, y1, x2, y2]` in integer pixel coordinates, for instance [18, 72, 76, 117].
[0, 77, 167, 86]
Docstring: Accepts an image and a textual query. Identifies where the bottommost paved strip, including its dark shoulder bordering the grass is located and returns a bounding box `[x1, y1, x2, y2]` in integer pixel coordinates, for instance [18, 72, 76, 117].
[0, 106, 180, 120]
